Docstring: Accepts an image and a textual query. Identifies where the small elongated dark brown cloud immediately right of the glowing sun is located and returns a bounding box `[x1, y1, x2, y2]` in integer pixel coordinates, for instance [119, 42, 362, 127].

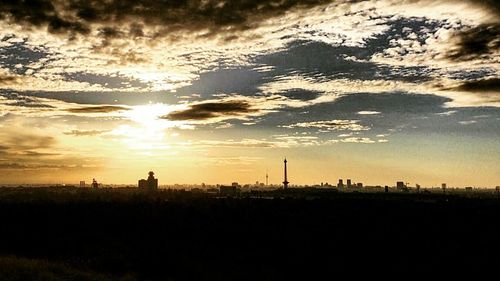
[162, 100, 257, 121]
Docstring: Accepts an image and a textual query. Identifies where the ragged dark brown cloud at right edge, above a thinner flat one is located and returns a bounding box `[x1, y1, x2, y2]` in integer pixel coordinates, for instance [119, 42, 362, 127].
[446, 23, 500, 61]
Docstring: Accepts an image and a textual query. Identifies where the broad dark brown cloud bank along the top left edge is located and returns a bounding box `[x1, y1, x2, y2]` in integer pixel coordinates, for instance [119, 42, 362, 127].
[0, 0, 333, 40]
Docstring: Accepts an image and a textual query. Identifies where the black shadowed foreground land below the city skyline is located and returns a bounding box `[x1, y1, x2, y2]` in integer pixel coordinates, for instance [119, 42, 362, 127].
[0, 188, 500, 280]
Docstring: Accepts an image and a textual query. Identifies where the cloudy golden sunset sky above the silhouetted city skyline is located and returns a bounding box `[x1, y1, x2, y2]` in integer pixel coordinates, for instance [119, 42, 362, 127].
[0, 0, 500, 187]
